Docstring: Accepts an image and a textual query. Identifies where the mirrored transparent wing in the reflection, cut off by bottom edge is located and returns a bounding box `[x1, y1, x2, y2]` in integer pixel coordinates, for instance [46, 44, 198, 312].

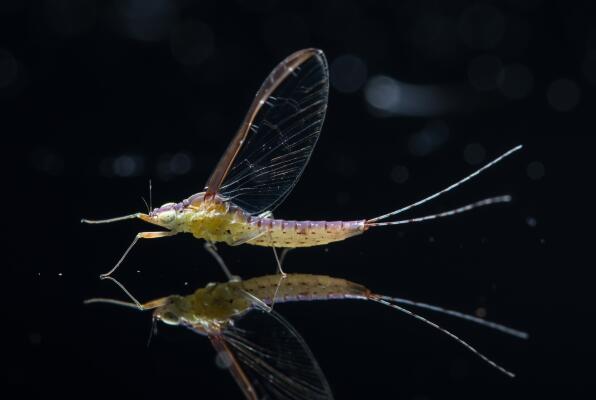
[210, 310, 333, 400]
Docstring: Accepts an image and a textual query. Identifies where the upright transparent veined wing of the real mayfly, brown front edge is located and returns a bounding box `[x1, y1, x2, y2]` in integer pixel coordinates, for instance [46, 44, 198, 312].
[205, 49, 329, 214]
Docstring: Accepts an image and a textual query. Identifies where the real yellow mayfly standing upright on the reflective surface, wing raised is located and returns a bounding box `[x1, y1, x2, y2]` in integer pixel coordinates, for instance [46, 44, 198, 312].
[82, 49, 521, 278]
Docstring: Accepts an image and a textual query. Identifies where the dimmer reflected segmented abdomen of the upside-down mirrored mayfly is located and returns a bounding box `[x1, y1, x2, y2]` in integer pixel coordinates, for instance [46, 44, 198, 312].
[240, 274, 370, 304]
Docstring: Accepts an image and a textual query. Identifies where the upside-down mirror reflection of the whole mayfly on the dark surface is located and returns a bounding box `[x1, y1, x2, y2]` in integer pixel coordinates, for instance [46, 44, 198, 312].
[85, 274, 528, 400]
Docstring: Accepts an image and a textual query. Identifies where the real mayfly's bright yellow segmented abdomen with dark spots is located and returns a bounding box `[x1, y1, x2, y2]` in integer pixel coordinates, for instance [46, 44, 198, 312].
[246, 216, 365, 248]
